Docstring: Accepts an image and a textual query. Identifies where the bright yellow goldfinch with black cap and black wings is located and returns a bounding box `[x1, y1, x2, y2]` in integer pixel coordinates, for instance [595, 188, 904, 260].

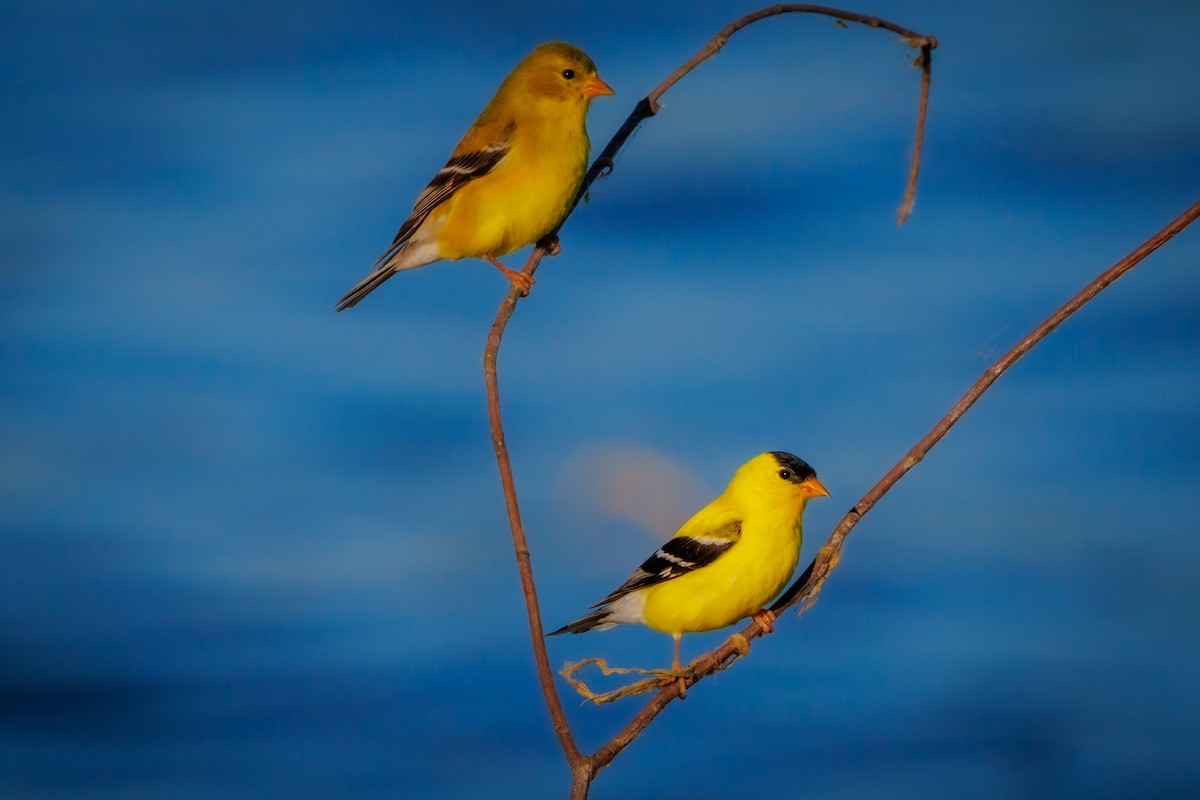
[550, 451, 829, 670]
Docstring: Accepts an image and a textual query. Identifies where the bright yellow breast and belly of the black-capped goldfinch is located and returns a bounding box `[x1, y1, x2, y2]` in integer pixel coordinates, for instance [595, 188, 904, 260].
[643, 513, 802, 634]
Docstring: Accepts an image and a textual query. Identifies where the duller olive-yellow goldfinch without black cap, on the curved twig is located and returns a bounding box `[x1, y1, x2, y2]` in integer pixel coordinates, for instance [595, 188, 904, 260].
[337, 42, 613, 311]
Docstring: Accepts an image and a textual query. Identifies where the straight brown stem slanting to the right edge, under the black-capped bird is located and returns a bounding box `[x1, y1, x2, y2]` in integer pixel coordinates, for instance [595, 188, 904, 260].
[592, 200, 1200, 771]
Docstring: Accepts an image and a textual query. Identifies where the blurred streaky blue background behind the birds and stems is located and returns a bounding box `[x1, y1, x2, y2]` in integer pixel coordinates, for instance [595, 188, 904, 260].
[0, 0, 1200, 799]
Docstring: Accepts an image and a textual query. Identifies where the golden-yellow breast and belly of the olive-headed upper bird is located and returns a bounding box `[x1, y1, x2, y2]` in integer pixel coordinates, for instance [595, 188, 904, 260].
[438, 109, 588, 259]
